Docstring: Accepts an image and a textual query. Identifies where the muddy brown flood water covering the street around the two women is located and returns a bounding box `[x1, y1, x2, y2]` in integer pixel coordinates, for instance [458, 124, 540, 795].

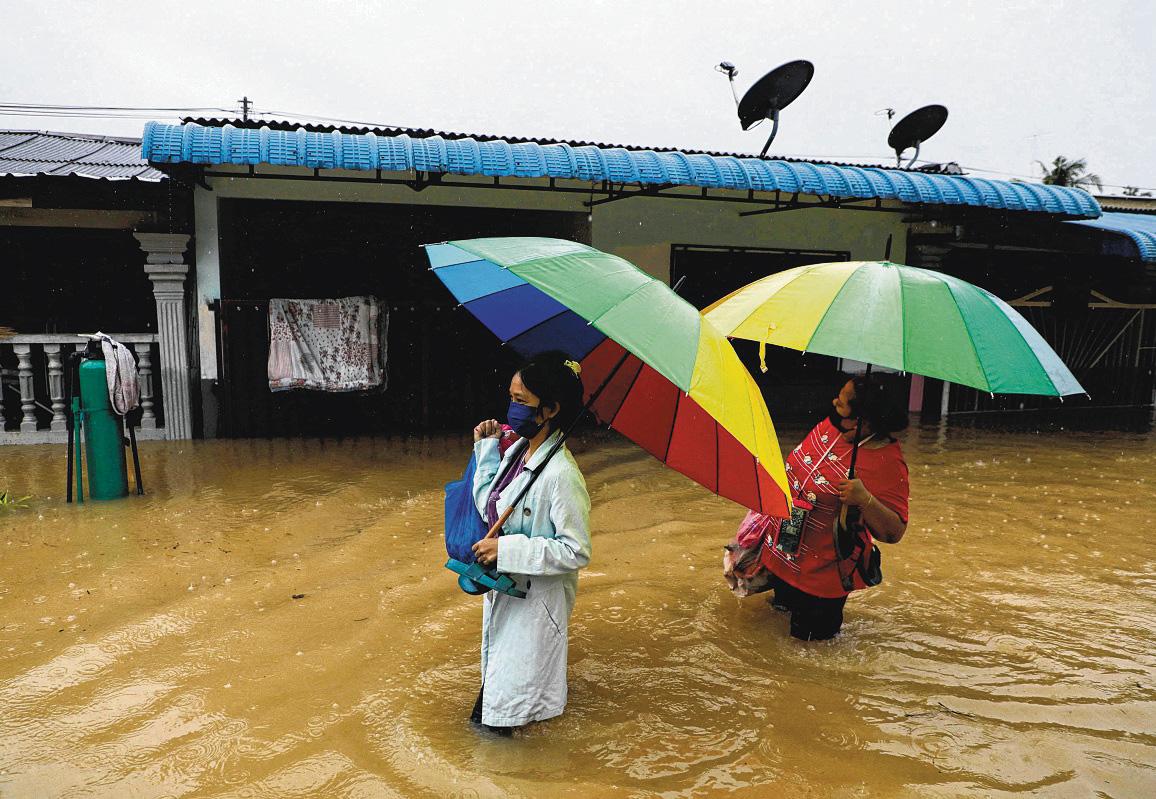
[0, 418, 1156, 799]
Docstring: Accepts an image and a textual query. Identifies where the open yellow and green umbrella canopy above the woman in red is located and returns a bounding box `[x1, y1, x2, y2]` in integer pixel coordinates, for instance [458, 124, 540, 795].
[703, 261, 1084, 397]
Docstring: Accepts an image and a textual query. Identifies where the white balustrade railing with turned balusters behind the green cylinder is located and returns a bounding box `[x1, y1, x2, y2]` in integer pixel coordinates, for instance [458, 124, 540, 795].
[0, 333, 164, 444]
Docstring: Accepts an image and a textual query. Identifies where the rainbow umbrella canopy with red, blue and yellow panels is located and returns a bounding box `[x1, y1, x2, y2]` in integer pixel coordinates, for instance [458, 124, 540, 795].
[425, 238, 790, 516]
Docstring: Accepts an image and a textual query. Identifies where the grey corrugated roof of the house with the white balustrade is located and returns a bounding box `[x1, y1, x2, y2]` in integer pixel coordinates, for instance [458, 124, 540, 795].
[0, 131, 165, 180]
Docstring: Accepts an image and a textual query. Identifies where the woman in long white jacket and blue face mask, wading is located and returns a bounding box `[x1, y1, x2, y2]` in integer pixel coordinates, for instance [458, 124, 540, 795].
[470, 353, 591, 734]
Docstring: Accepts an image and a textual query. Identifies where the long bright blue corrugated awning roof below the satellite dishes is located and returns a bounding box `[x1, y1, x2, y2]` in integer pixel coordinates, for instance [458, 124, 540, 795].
[141, 121, 1101, 217]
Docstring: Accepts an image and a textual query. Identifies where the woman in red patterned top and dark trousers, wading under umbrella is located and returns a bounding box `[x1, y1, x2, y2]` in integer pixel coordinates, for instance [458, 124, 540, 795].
[748, 376, 909, 641]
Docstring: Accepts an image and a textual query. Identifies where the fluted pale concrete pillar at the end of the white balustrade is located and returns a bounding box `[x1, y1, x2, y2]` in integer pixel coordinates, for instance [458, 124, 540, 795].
[133, 234, 193, 441]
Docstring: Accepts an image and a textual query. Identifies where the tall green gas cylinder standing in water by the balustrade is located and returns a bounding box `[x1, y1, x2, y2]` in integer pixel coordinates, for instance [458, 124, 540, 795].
[80, 358, 128, 500]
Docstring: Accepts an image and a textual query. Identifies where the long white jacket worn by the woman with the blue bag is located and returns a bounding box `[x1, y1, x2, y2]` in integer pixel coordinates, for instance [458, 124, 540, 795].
[474, 432, 591, 726]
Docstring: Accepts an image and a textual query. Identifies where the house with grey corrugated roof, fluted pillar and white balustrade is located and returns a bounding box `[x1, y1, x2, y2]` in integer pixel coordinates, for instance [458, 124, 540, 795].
[0, 131, 193, 443]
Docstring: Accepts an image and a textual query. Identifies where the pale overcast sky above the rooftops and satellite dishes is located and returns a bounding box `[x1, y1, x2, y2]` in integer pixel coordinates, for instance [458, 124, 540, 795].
[0, 0, 1156, 193]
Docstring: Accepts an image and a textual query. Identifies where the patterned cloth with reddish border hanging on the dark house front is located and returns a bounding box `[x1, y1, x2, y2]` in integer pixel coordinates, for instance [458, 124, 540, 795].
[268, 297, 390, 391]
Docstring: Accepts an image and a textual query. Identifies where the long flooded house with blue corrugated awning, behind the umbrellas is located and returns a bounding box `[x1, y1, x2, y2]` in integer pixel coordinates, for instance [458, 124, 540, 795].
[0, 119, 1156, 437]
